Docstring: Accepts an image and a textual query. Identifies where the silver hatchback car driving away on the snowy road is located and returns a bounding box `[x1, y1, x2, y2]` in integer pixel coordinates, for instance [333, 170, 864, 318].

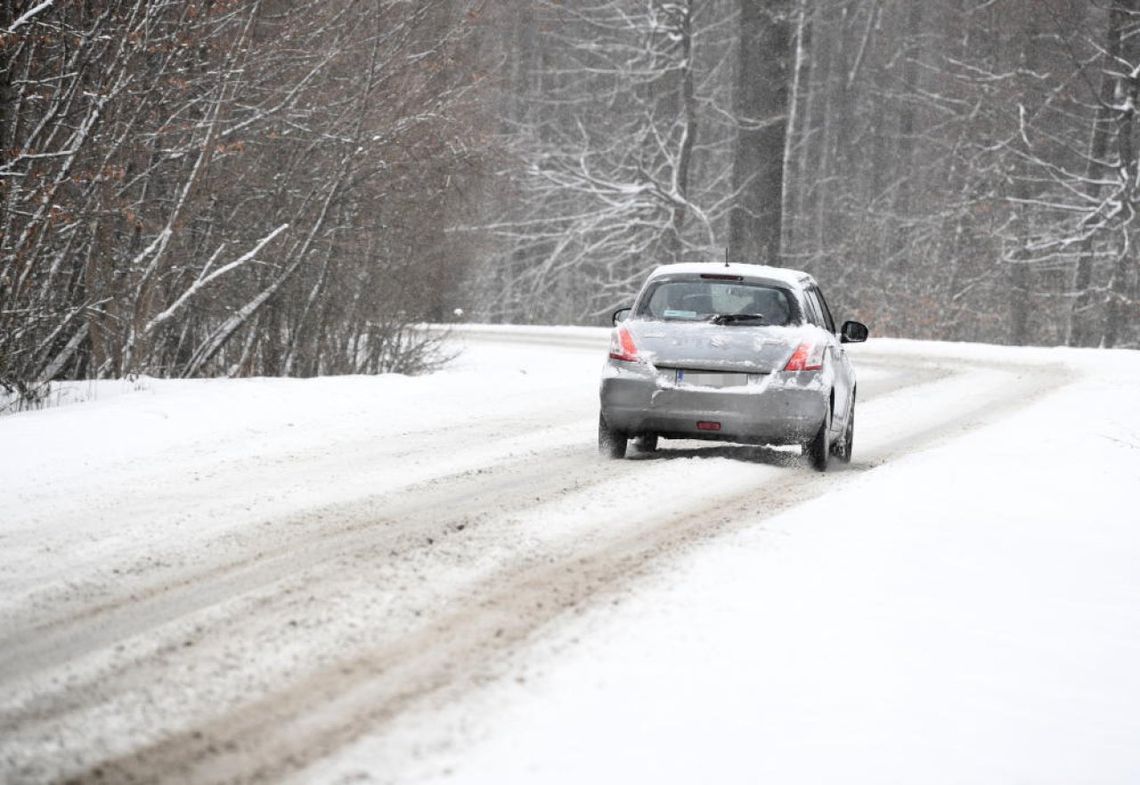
[597, 264, 868, 471]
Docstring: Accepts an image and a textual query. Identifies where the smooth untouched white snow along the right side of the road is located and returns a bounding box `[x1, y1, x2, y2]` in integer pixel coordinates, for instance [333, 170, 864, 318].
[302, 341, 1140, 785]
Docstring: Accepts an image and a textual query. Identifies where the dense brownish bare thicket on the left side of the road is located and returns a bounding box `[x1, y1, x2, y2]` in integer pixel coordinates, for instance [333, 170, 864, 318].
[0, 0, 483, 392]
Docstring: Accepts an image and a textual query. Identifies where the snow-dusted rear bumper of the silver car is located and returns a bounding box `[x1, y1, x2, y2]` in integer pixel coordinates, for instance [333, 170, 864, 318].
[601, 363, 829, 444]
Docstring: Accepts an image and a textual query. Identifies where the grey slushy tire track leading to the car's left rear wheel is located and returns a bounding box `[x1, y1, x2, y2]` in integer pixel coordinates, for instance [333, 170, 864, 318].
[0, 447, 611, 683]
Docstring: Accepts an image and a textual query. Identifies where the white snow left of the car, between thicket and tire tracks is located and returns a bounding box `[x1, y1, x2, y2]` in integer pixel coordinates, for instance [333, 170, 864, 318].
[0, 330, 605, 621]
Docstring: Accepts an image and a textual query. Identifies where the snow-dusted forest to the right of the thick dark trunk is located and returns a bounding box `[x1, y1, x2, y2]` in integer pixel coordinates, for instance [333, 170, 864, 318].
[783, 0, 1140, 346]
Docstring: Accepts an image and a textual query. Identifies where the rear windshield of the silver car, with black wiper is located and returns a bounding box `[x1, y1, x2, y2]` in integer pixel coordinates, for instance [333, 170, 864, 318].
[637, 279, 796, 326]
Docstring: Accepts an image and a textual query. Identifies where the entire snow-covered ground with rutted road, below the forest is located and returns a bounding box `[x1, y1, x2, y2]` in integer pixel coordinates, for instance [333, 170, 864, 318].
[0, 328, 1140, 783]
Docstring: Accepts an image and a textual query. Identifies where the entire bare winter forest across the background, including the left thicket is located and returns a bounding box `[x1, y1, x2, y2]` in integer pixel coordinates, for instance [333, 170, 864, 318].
[0, 0, 1140, 399]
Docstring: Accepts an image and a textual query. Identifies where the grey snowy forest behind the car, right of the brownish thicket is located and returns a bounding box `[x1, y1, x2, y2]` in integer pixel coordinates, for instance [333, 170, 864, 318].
[475, 0, 1140, 346]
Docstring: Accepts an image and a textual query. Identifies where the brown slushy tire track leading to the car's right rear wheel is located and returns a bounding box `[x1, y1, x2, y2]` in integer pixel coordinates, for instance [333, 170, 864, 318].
[28, 353, 1069, 783]
